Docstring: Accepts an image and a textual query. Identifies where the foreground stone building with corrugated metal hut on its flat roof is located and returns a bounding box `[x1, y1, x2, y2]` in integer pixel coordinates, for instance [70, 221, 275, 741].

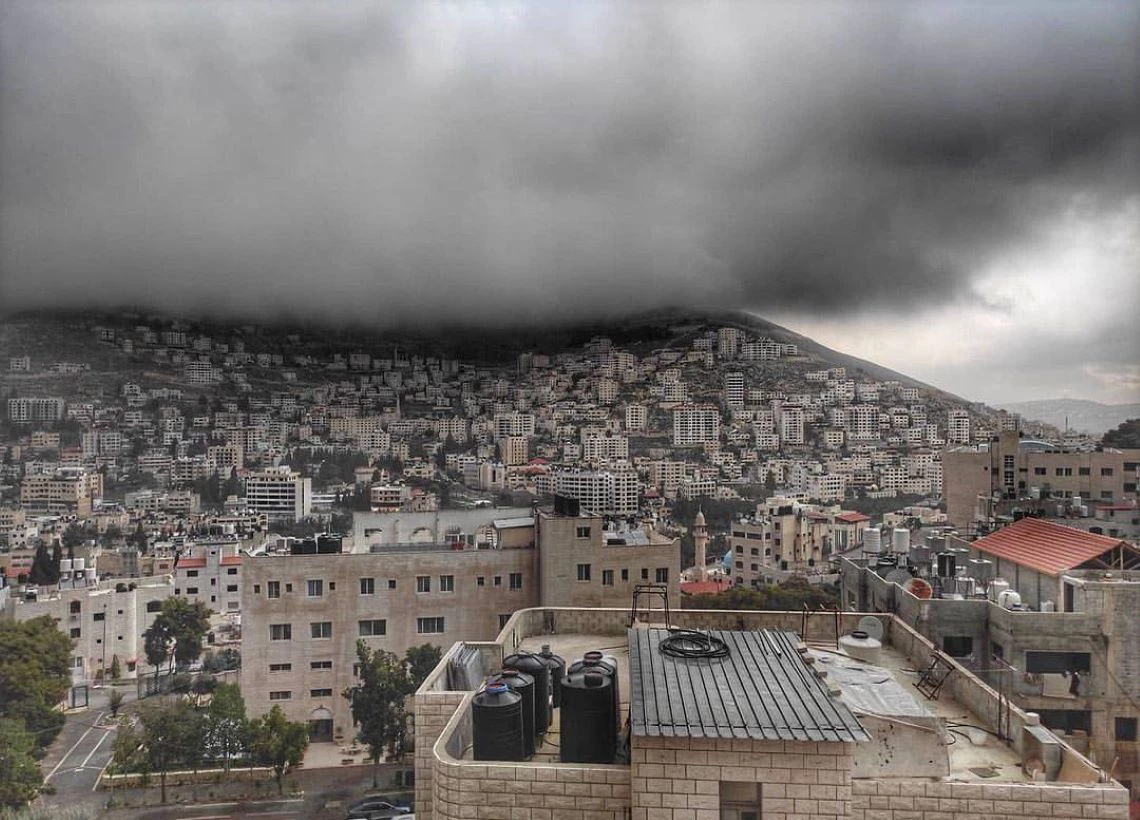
[415, 608, 1127, 820]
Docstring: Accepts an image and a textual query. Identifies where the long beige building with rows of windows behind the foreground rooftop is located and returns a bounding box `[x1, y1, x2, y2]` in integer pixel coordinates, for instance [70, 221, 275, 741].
[242, 501, 679, 740]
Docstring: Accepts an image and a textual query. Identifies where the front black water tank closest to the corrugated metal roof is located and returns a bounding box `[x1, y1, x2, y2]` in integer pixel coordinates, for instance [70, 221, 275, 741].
[559, 667, 618, 763]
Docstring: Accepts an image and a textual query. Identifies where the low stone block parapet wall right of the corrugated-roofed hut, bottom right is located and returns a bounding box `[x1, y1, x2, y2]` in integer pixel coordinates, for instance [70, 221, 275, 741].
[852, 780, 1129, 820]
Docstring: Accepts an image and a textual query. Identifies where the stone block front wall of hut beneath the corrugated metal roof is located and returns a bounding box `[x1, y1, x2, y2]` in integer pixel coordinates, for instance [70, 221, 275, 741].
[629, 737, 852, 820]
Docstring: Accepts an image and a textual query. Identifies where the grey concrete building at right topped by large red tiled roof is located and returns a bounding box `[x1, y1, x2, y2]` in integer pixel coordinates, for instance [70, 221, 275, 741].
[840, 519, 1140, 799]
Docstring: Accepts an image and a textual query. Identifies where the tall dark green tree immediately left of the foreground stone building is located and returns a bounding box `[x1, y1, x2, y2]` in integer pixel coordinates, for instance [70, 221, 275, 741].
[343, 641, 426, 788]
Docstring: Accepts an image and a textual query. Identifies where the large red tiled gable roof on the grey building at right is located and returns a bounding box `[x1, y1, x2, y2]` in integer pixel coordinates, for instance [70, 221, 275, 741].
[971, 518, 1127, 577]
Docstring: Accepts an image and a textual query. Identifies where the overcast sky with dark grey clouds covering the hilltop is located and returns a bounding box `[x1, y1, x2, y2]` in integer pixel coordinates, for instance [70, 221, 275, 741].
[0, 0, 1140, 401]
